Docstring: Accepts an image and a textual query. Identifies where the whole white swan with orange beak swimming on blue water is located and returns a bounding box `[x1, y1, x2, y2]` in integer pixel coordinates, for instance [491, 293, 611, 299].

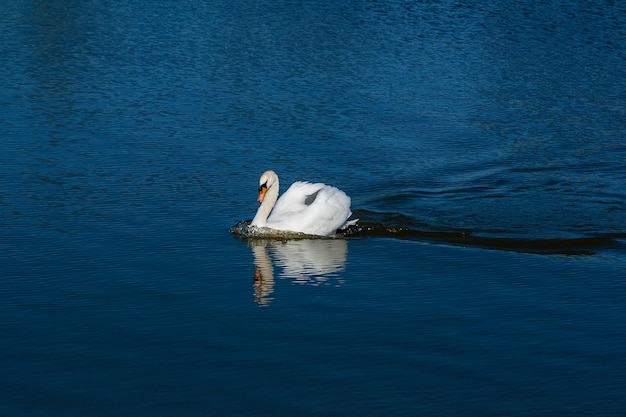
[250, 171, 357, 236]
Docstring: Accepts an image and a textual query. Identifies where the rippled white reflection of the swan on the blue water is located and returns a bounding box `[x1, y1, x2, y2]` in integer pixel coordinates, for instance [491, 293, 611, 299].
[250, 239, 348, 306]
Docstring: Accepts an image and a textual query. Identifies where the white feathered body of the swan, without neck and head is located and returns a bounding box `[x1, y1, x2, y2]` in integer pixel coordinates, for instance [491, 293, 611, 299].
[267, 181, 352, 236]
